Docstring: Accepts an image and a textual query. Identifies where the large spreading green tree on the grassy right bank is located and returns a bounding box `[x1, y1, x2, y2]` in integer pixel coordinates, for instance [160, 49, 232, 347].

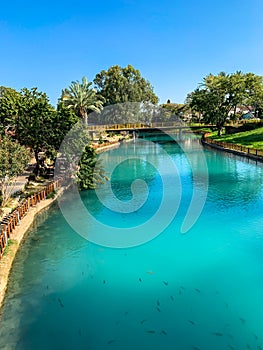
[187, 72, 263, 135]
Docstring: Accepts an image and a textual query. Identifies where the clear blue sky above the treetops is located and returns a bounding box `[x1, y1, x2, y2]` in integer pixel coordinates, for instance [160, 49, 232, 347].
[0, 0, 263, 105]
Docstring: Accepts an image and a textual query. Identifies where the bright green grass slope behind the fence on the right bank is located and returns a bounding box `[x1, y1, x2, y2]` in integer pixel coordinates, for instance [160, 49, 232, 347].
[210, 127, 263, 149]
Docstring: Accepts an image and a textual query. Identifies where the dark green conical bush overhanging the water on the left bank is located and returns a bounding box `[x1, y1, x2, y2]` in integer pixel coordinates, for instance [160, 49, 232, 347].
[77, 145, 107, 190]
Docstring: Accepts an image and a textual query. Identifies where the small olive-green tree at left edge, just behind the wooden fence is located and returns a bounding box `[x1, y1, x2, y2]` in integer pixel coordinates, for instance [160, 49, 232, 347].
[0, 136, 29, 206]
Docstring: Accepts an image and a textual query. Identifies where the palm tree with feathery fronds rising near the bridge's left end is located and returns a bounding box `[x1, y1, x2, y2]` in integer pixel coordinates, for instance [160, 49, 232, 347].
[61, 77, 103, 125]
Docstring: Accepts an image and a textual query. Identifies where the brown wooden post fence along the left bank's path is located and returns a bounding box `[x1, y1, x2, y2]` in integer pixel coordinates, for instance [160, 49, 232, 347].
[0, 178, 63, 259]
